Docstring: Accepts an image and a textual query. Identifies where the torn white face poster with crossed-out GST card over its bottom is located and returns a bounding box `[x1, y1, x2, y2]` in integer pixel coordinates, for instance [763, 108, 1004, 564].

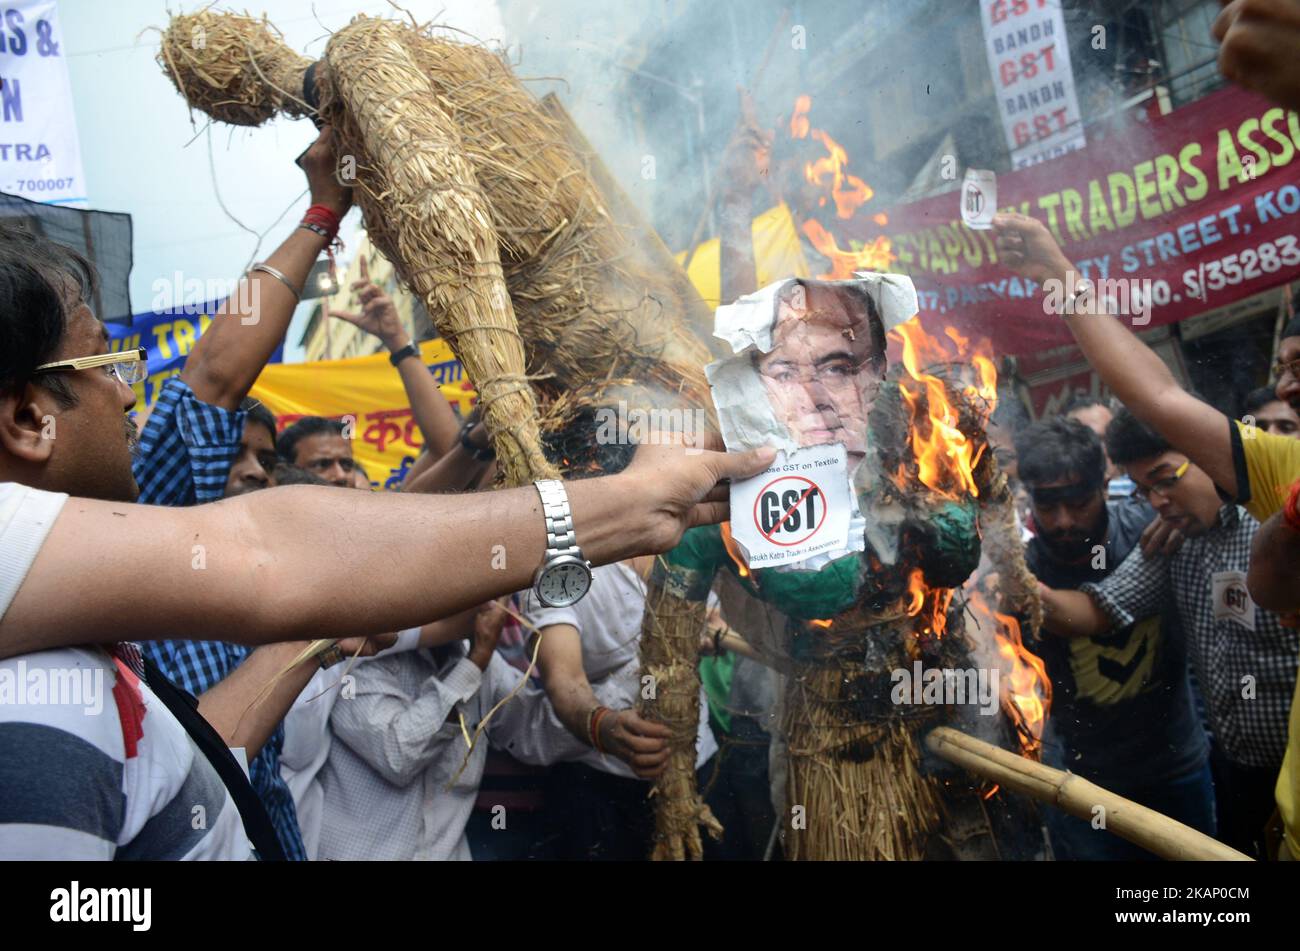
[705, 272, 917, 570]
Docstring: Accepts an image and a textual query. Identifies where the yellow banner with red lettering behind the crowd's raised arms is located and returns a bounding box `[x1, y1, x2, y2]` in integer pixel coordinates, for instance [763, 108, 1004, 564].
[248, 340, 478, 488]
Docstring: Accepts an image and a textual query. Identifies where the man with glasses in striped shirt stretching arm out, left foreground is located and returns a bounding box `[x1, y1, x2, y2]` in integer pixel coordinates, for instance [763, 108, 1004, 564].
[0, 229, 772, 859]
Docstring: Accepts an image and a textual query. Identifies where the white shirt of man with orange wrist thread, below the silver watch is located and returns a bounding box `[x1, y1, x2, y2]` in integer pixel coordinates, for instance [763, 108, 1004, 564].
[524, 563, 718, 778]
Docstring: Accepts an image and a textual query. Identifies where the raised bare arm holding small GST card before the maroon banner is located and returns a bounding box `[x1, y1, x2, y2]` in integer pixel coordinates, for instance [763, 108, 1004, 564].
[993, 213, 1238, 496]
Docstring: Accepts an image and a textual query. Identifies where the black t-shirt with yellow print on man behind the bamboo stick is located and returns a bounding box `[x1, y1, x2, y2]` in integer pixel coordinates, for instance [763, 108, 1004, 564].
[1026, 498, 1209, 791]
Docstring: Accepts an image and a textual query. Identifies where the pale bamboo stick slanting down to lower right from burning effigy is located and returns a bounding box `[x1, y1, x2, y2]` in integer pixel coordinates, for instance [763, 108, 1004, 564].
[926, 726, 1251, 861]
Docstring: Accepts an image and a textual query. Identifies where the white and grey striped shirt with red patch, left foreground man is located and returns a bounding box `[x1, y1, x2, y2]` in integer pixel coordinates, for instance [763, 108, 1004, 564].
[0, 483, 252, 860]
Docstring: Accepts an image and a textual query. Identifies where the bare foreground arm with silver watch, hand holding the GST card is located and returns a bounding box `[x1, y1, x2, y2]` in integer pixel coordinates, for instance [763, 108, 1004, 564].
[0, 446, 774, 656]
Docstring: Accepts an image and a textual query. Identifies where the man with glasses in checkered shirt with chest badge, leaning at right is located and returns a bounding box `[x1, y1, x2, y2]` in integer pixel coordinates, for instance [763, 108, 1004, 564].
[1043, 411, 1300, 857]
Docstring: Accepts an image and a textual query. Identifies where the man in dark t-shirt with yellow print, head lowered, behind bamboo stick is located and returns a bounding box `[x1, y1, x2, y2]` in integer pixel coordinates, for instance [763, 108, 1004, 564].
[1015, 417, 1214, 860]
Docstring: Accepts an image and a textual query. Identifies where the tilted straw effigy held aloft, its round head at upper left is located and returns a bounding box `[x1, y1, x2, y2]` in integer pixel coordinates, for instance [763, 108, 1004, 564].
[159, 10, 709, 483]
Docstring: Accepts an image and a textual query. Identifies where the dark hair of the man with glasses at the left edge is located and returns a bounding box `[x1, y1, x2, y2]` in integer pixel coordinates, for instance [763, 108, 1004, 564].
[0, 225, 98, 407]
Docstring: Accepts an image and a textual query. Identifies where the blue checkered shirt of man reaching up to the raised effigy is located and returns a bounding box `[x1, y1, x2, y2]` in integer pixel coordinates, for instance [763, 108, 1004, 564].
[134, 377, 307, 861]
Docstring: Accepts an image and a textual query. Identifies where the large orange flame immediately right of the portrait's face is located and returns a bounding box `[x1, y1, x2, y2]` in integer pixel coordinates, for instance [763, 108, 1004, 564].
[891, 318, 997, 500]
